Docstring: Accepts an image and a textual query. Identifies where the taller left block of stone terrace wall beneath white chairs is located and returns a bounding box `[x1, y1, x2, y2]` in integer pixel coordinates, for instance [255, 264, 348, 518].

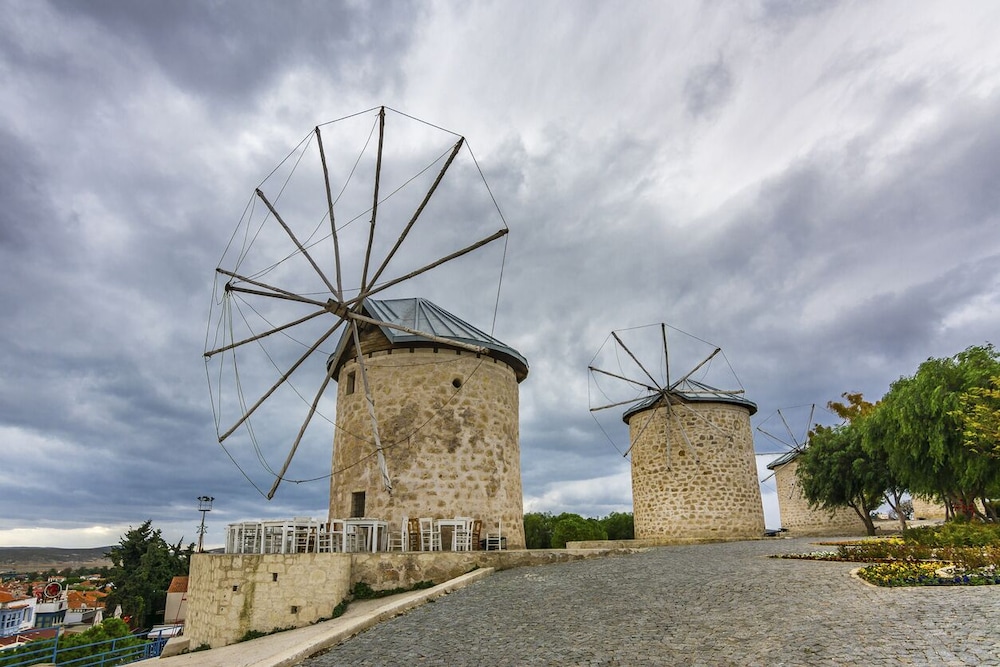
[184, 553, 351, 648]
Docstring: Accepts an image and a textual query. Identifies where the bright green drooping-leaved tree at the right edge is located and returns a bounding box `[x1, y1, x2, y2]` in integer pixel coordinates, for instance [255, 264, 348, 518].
[864, 345, 1000, 517]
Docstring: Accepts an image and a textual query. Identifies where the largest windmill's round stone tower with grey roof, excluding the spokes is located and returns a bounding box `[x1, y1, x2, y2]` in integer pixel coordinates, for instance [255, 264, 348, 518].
[329, 299, 528, 548]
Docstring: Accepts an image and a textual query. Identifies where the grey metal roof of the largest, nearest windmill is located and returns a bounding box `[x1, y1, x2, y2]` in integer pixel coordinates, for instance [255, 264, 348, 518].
[330, 297, 528, 382]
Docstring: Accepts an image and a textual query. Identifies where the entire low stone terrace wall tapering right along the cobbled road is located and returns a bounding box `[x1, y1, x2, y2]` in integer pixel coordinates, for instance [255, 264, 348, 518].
[184, 544, 636, 649]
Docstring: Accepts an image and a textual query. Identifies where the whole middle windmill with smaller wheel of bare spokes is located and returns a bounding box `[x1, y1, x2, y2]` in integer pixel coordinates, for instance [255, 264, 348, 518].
[590, 324, 764, 541]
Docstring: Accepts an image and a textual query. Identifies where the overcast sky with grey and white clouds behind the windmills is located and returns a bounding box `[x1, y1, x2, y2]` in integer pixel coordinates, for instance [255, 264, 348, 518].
[0, 0, 1000, 547]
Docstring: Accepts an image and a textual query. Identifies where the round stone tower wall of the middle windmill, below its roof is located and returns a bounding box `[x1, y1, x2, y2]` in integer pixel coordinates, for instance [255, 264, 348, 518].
[629, 403, 764, 539]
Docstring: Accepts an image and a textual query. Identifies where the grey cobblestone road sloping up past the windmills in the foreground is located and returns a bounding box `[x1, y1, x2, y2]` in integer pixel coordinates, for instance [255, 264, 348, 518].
[302, 539, 1000, 667]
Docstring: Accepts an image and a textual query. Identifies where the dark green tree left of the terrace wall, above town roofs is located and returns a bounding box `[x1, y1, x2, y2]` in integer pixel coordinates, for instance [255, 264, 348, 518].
[104, 520, 194, 628]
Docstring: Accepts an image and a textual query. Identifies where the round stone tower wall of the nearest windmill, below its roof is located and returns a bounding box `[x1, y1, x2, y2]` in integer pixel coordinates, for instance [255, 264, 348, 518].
[330, 350, 524, 549]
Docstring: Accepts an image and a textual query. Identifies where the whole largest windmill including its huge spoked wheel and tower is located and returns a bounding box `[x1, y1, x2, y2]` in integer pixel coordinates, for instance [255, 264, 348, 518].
[205, 107, 528, 547]
